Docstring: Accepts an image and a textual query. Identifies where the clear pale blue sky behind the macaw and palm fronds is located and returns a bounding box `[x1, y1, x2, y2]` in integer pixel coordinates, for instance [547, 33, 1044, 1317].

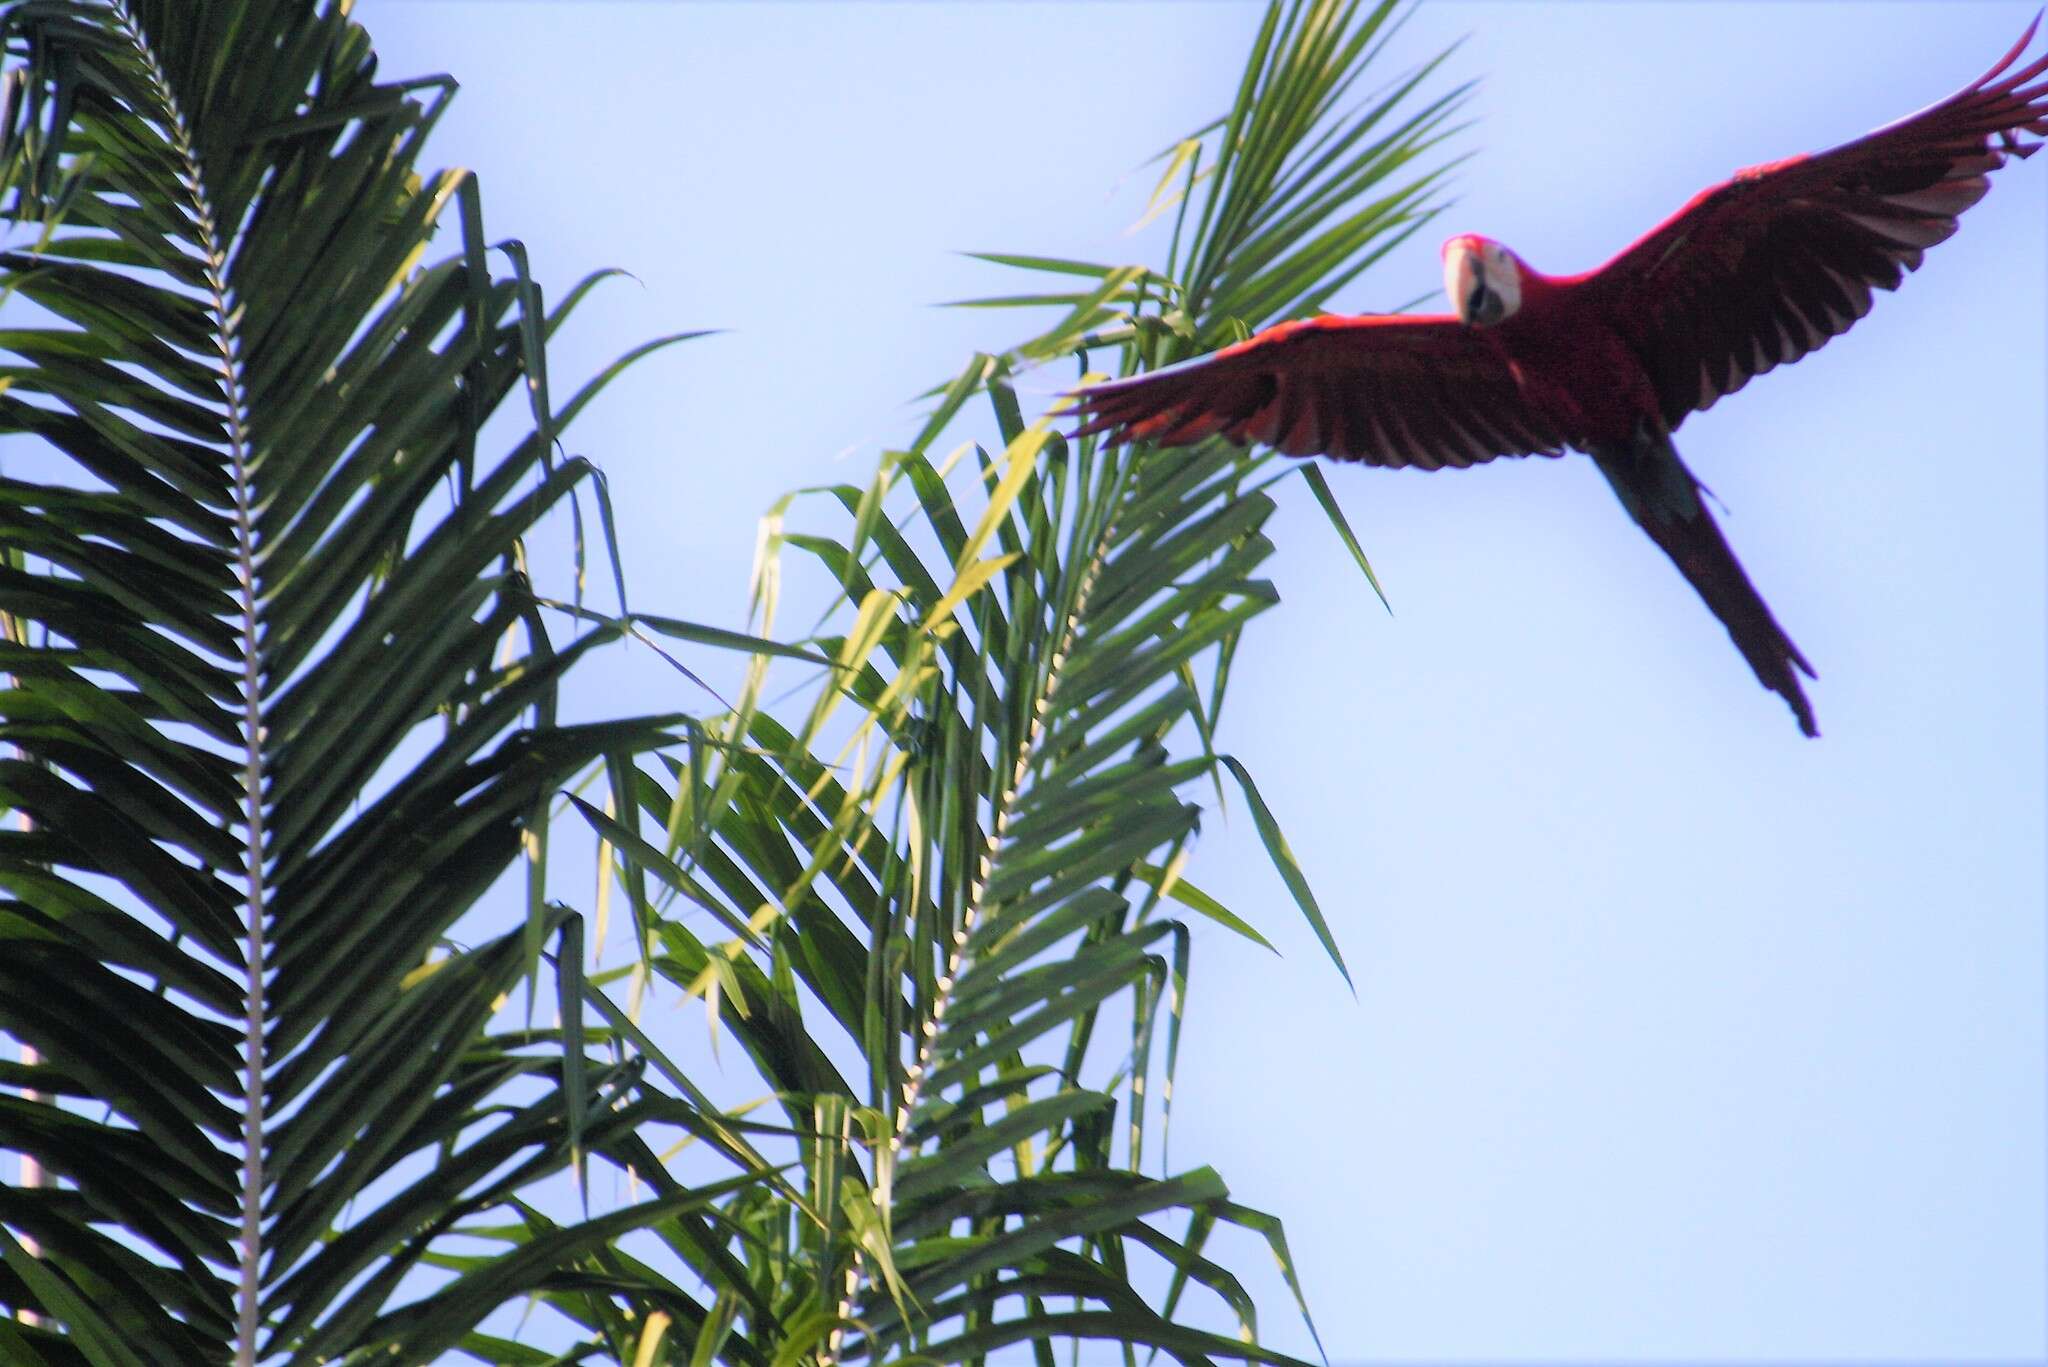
[358, 0, 2048, 1361]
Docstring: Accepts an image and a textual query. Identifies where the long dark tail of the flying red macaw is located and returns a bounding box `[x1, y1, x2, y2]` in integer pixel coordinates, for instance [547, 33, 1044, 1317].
[1591, 424, 1821, 736]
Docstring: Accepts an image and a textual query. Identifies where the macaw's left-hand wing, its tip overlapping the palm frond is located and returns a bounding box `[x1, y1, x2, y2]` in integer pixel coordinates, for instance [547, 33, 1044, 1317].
[1075, 314, 1565, 469]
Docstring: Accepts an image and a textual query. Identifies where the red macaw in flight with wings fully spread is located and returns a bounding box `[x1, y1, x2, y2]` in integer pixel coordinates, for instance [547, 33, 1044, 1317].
[1077, 14, 2048, 736]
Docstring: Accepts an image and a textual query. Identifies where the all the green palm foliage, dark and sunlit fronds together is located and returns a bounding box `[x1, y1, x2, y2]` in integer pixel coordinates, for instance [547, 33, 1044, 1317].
[0, 0, 1462, 1363]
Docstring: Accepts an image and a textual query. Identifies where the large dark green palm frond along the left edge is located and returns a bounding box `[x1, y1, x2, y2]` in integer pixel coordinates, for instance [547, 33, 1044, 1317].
[0, 0, 752, 1363]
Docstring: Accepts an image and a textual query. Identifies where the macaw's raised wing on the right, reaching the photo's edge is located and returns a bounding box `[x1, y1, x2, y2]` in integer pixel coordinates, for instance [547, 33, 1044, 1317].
[1575, 14, 2048, 426]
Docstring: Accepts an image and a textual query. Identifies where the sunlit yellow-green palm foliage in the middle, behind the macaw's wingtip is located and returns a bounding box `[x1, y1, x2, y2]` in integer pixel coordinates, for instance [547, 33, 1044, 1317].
[483, 0, 1460, 1361]
